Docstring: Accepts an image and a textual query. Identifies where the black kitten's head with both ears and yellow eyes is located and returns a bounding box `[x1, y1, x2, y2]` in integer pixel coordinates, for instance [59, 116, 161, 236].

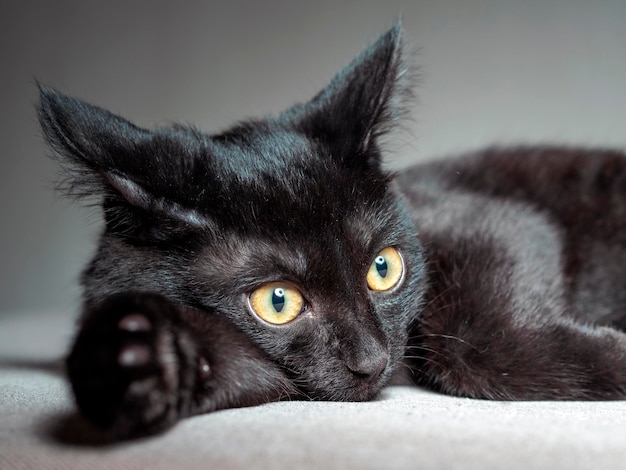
[39, 26, 423, 400]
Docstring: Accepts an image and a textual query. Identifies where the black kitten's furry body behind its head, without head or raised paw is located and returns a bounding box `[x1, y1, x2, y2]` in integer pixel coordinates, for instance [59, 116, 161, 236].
[398, 147, 626, 399]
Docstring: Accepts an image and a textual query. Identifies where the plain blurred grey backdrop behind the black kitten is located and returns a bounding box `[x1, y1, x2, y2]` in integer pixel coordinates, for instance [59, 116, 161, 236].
[0, 0, 626, 315]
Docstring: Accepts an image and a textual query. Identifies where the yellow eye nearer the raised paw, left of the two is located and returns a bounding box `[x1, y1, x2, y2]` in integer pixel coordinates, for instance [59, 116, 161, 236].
[250, 282, 304, 325]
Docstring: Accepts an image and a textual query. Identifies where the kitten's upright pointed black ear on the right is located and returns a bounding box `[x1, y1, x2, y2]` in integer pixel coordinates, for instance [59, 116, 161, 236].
[288, 23, 414, 167]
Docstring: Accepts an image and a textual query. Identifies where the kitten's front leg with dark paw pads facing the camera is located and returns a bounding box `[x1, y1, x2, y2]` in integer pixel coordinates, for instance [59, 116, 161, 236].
[67, 292, 291, 439]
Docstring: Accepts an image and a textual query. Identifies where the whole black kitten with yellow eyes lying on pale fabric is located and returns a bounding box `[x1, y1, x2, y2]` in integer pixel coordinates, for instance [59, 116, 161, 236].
[38, 24, 626, 439]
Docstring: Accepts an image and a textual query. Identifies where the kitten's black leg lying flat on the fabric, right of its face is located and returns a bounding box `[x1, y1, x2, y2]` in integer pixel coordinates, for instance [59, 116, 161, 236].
[407, 315, 626, 400]
